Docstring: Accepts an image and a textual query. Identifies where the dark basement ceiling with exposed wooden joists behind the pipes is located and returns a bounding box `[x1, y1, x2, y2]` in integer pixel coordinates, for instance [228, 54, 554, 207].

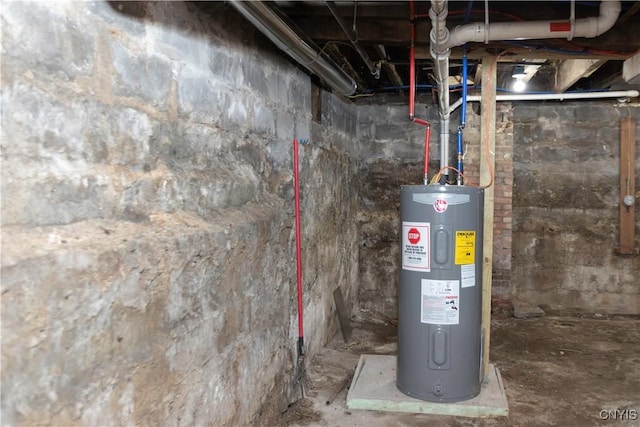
[234, 0, 640, 98]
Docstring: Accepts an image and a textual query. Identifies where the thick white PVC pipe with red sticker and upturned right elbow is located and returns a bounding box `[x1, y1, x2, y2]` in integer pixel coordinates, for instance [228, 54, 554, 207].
[445, 0, 620, 48]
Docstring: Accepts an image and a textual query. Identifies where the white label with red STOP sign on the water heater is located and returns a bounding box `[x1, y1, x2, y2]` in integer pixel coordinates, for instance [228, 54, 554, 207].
[402, 221, 431, 272]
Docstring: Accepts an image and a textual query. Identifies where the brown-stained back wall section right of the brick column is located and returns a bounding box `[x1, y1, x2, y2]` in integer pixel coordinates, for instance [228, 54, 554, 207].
[512, 101, 640, 314]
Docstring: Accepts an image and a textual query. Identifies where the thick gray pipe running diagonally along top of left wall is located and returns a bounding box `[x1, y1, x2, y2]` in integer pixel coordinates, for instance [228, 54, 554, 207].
[229, 0, 357, 96]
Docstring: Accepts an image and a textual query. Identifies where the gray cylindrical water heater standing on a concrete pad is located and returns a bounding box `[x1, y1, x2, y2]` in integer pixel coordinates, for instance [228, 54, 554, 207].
[397, 185, 484, 402]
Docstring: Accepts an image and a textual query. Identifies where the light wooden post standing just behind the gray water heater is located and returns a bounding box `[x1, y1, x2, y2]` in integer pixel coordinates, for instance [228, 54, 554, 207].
[480, 57, 498, 379]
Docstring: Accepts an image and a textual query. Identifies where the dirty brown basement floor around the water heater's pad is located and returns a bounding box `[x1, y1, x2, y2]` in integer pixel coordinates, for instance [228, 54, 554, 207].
[281, 312, 640, 427]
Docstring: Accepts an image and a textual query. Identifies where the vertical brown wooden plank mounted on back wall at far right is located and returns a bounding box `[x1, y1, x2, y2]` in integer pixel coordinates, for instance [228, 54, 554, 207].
[617, 117, 636, 255]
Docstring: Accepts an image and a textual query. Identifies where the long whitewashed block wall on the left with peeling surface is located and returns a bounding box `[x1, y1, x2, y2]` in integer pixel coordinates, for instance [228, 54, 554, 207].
[0, 1, 358, 425]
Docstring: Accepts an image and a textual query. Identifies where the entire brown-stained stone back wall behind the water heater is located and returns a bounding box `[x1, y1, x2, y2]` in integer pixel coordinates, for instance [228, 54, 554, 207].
[358, 98, 640, 315]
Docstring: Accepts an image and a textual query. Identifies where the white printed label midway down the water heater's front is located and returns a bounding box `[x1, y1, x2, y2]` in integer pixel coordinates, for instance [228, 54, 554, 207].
[420, 279, 460, 325]
